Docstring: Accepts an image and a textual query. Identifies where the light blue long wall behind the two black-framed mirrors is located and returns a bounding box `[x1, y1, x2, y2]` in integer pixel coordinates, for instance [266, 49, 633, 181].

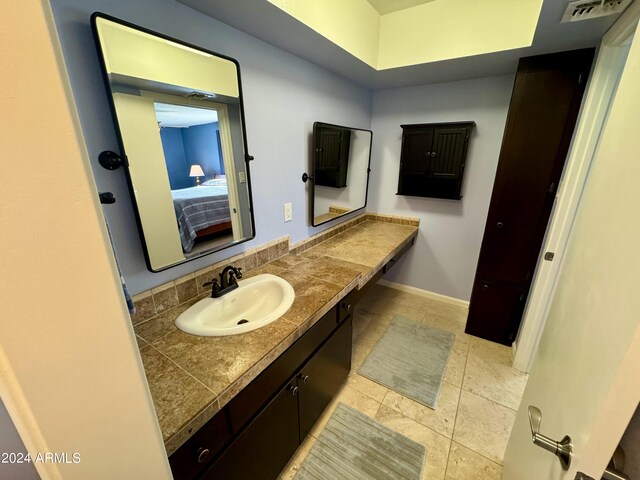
[51, 0, 371, 294]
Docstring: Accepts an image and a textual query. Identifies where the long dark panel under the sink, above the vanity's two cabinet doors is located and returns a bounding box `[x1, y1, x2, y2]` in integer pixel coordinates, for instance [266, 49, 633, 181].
[228, 308, 338, 433]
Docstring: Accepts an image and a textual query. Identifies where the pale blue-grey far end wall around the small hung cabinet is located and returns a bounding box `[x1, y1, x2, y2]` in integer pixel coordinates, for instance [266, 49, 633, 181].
[369, 75, 514, 300]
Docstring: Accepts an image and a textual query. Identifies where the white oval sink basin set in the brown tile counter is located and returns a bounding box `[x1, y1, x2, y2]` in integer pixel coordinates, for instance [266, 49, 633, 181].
[176, 274, 295, 337]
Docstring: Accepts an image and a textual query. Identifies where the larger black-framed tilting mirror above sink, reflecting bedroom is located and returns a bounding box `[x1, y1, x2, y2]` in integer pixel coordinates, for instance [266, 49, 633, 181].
[92, 13, 255, 272]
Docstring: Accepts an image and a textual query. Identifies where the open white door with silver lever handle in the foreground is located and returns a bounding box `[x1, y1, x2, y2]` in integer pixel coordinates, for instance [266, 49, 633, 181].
[502, 2, 640, 480]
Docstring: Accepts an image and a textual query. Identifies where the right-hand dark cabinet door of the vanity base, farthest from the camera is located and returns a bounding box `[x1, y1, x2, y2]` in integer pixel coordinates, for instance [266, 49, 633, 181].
[298, 317, 352, 440]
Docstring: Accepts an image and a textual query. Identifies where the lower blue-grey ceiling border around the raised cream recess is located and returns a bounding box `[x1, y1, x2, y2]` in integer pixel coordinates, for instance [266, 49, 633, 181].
[178, 0, 619, 89]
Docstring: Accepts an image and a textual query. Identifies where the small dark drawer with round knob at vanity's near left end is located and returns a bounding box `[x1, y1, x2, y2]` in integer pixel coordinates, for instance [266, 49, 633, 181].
[169, 409, 231, 480]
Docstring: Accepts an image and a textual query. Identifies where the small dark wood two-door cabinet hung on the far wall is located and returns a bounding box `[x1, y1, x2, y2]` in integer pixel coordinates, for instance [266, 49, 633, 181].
[398, 122, 475, 200]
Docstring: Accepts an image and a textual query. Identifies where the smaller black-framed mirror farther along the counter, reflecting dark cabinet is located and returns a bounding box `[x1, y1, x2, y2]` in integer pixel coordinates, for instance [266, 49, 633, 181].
[306, 122, 373, 227]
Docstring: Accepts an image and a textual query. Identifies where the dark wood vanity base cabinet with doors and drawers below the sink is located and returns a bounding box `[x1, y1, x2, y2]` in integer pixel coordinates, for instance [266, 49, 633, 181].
[169, 292, 355, 480]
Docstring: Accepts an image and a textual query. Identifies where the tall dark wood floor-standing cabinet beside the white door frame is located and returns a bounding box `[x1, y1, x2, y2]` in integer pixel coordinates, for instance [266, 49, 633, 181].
[466, 49, 594, 345]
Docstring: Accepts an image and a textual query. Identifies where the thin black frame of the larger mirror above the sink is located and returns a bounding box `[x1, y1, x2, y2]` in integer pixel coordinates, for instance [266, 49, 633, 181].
[91, 12, 256, 273]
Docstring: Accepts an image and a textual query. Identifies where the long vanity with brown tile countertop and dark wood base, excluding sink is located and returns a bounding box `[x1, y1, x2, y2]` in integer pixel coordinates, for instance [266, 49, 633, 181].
[135, 214, 418, 479]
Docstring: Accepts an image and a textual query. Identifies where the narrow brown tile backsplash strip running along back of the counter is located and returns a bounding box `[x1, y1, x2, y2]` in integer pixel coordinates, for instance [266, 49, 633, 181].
[131, 213, 419, 325]
